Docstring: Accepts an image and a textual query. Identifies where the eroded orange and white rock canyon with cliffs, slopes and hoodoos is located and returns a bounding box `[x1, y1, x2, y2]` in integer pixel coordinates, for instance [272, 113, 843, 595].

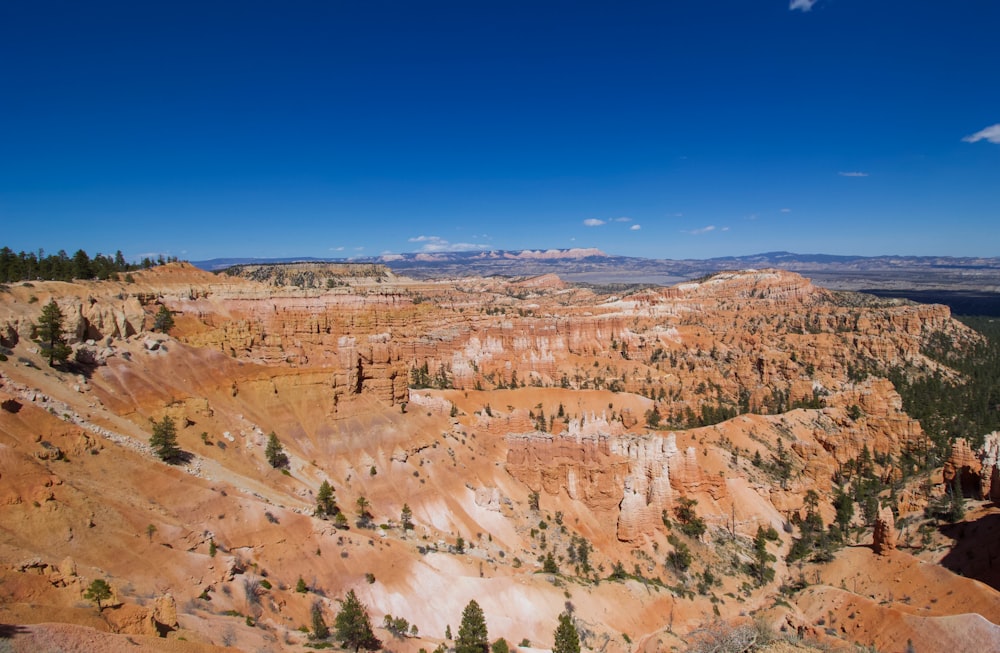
[0, 263, 1000, 653]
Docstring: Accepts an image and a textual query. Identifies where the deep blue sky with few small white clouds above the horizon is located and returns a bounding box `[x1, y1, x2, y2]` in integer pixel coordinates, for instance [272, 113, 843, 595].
[0, 0, 1000, 260]
